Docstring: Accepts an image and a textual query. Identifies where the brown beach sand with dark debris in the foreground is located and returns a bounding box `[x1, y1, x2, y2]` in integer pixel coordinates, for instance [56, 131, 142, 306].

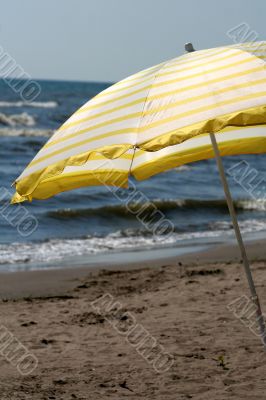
[0, 241, 266, 400]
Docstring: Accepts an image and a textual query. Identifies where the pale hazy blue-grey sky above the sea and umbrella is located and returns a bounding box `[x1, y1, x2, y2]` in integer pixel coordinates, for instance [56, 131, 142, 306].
[0, 0, 266, 81]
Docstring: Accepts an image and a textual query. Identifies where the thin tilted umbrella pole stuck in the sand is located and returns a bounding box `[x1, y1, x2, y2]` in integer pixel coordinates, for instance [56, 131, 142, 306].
[210, 133, 266, 348]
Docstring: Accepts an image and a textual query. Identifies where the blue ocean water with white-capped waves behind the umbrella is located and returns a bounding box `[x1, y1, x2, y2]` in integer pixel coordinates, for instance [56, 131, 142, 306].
[0, 80, 266, 269]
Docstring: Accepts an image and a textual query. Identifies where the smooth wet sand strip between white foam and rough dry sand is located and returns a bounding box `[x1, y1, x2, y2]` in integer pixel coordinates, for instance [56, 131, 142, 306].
[0, 239, 266, 299]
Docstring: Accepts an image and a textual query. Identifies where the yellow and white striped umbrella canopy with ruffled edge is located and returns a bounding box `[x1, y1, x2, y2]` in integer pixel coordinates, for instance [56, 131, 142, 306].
[13, 42, 266, 202]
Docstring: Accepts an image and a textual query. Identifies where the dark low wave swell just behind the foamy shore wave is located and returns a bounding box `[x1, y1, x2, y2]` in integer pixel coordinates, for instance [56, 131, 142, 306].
[47, 199, 266, 219]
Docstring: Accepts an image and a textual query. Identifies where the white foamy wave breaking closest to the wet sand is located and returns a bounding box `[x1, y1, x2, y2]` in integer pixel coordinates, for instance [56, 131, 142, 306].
[0, 219, 266, 267]
